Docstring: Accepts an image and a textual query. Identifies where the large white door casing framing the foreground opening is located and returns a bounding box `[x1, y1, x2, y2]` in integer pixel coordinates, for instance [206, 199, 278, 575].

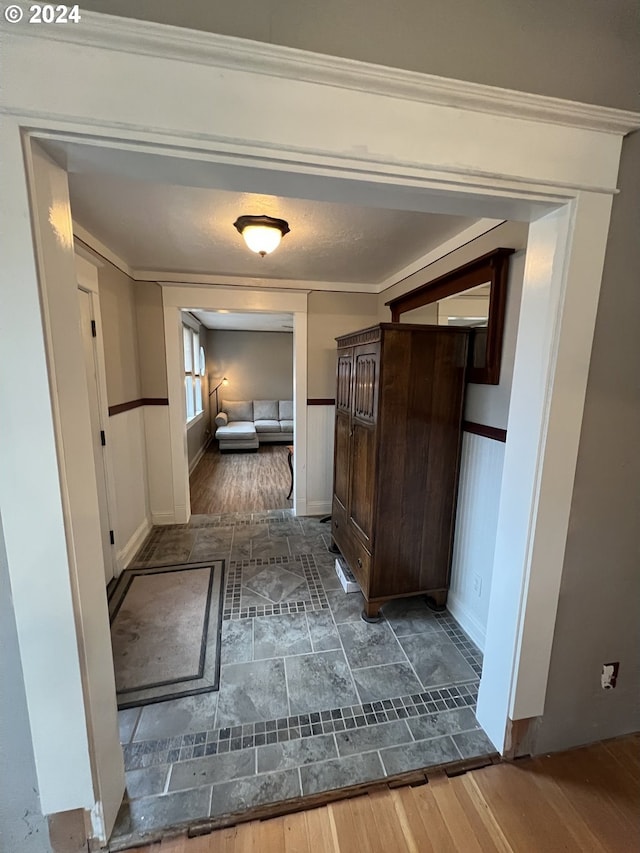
[0, 10, 639, 828]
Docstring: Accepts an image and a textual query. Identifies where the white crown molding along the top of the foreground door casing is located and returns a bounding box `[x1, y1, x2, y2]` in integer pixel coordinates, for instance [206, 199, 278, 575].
[12, 6, 640, 135]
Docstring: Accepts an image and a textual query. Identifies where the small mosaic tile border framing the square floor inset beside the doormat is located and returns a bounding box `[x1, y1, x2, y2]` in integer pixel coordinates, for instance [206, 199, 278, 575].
[222, 554, 329, 621]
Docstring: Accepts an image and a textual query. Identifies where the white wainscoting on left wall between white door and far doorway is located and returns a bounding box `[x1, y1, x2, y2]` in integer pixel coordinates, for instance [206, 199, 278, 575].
[108, 406, 151, 569]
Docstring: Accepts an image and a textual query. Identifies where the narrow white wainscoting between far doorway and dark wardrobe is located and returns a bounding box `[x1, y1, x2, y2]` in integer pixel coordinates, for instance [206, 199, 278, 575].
[307, 405, 335, 515]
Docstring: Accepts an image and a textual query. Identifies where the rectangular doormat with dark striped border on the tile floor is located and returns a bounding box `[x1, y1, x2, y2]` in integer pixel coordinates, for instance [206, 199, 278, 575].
[109, 560, 224, 709]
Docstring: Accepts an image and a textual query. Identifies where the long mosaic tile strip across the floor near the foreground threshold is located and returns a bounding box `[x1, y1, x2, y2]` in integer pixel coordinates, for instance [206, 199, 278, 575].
[123, 681, 479, 771]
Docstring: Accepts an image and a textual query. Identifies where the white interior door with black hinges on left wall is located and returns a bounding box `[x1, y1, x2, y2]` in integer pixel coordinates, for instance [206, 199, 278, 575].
[78, 288, 115, 583]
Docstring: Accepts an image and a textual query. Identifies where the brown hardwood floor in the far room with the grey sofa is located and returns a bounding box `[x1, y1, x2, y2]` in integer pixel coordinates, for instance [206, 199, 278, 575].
[189, 443, 293, 514]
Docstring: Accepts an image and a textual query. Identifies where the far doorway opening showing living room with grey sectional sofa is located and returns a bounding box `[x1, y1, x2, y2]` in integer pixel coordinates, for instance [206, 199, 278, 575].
[183, 308, 295, 515]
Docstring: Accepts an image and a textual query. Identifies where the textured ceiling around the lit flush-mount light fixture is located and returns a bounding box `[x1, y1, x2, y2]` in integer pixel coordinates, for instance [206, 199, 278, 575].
[69, 173, 474, 284]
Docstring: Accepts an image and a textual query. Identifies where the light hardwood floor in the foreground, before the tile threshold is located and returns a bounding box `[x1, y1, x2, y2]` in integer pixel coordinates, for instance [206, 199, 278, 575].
[122, 735, 640, 853]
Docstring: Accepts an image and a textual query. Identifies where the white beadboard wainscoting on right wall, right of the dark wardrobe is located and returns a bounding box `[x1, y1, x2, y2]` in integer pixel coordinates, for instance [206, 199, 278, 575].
[448, 432, 505, 650]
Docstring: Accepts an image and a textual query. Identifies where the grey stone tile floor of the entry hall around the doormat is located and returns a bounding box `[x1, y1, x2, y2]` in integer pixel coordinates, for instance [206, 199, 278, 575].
[111, 510, 494, 850]
